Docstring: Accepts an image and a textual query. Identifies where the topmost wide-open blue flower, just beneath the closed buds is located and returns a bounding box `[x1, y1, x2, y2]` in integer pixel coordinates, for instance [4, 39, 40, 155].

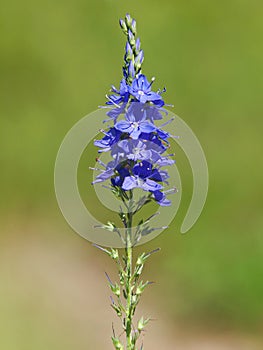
[129, 74, 164, 107]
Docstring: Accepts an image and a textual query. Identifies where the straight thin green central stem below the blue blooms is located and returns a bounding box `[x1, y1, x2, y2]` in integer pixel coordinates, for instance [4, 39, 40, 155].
[125, 212, 133, 350]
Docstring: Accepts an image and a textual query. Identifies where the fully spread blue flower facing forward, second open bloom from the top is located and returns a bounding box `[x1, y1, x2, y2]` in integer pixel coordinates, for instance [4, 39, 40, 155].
[115, 107, 156, 140]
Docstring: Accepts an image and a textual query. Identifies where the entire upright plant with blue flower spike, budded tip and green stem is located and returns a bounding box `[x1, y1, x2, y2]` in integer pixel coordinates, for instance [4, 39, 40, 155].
[91, 14, 175, 350]
